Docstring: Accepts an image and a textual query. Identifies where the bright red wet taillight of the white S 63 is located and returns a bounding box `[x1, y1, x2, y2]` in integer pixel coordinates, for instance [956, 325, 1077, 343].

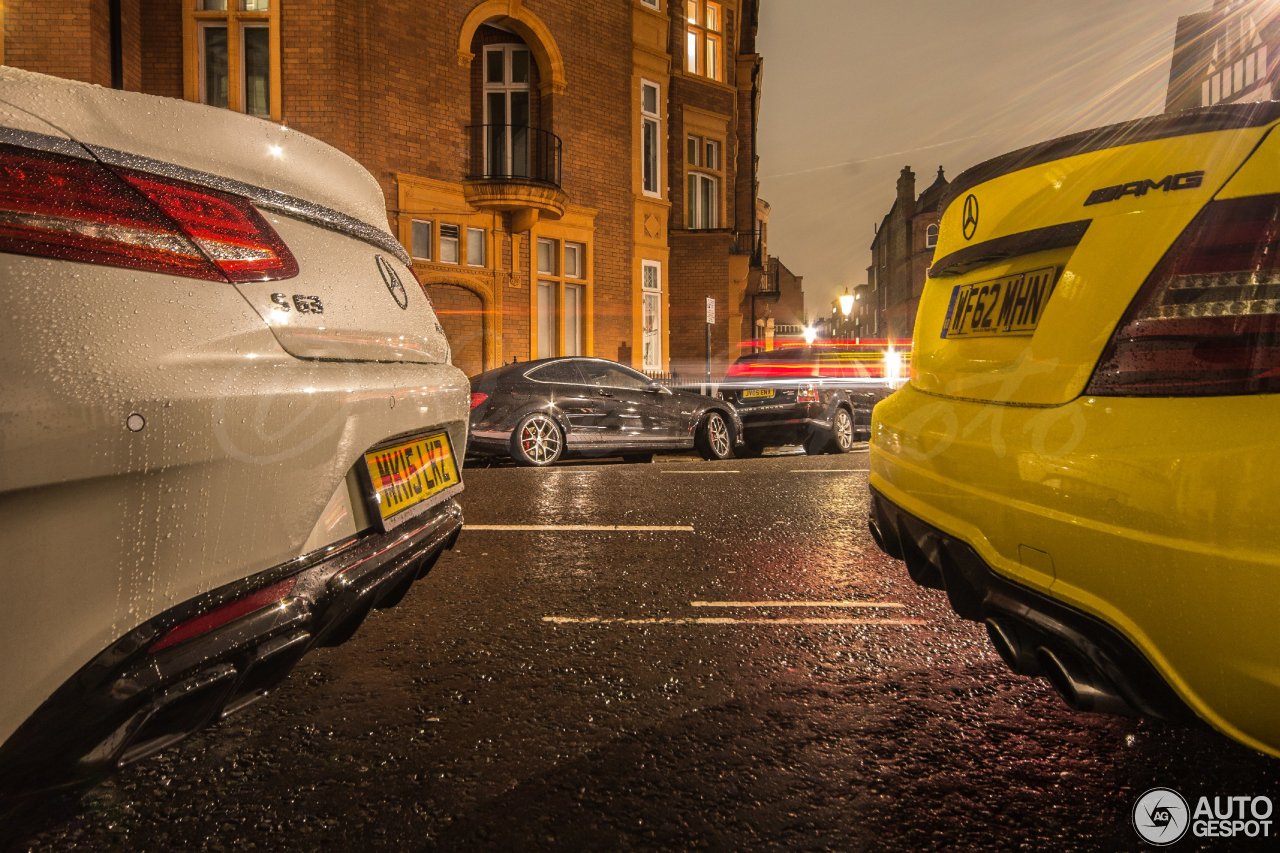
[0, 145, 298, 282]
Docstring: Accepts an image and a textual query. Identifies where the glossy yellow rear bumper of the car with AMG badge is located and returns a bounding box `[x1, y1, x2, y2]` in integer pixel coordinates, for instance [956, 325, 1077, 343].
[870, 386, 1280, 756]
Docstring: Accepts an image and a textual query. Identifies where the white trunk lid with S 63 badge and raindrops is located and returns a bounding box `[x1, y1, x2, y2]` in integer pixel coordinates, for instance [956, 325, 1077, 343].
[0, 68, 449, 362]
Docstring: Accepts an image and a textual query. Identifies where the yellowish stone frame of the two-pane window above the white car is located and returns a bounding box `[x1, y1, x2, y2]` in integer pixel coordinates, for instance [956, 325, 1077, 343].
[182, 0, 283, 122]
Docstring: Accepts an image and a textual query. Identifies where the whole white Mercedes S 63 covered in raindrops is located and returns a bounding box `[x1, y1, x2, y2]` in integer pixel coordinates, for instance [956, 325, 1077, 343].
[0, 68, 468, 799]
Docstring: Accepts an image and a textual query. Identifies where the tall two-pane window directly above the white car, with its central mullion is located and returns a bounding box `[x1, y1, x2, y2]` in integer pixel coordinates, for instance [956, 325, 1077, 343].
[183, 0, 280, 119]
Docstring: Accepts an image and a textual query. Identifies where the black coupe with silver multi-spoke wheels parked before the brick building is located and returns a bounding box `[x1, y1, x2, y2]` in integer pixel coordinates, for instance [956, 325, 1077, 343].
[470, 357, 742, 466]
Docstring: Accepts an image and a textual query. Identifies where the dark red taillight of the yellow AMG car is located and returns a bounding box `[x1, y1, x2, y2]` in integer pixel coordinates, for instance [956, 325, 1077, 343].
[1085, 196, 1280, 397]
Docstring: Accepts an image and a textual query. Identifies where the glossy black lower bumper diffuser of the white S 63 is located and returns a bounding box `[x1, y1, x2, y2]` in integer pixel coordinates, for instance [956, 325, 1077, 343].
[0, 500, 462, 799]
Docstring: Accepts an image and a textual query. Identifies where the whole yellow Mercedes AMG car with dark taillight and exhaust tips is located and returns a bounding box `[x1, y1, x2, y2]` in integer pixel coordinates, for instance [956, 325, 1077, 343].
[870, 102, 1280, 756]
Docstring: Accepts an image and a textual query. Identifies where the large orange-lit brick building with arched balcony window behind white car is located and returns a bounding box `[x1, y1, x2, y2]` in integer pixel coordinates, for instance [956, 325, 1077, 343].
[0, 0, 762, 373]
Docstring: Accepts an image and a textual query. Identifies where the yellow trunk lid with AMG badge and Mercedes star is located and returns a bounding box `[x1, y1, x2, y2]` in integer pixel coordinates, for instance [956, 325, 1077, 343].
[911, 104, 1280, 406]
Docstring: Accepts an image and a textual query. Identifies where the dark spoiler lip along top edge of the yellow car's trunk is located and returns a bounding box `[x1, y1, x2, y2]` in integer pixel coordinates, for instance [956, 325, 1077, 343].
[938, 101, 1280, 204]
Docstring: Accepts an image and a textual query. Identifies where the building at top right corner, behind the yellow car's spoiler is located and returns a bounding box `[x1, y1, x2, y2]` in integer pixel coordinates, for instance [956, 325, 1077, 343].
[1165, 0, 1280, 113]
